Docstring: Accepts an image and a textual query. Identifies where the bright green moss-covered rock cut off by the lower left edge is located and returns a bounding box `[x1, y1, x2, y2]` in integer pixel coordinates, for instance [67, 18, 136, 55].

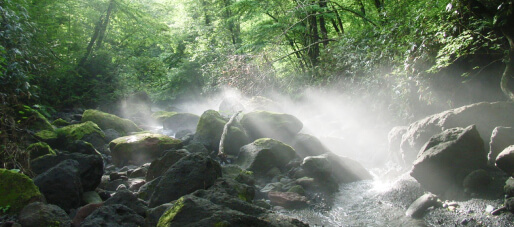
[0, 169, 44, 214]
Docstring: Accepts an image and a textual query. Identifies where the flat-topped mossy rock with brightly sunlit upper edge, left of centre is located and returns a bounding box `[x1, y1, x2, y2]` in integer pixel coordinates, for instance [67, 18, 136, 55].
[109, 133, 182, 166]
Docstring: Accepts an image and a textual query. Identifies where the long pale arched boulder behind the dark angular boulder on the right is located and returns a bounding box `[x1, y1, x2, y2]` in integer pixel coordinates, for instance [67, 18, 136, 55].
[401, 102, 514, 165]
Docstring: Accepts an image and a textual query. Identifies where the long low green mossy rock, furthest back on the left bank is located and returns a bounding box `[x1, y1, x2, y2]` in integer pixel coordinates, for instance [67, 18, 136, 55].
[82, 109, 142, 135]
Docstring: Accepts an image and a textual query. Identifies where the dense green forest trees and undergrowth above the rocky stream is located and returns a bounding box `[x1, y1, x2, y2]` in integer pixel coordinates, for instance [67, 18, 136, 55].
[0, 0, 514, 168]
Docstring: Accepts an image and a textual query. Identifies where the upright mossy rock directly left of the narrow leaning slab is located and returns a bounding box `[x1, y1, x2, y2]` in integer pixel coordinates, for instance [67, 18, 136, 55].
[193, 110, 227, 151]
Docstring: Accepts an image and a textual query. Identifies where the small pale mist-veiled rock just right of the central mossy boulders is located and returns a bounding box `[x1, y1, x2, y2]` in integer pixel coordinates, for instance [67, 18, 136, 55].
[291, 133, 329, 159]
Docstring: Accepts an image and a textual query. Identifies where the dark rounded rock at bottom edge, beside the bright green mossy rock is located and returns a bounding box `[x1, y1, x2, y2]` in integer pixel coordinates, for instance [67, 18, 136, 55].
[18, 202, 71, 227]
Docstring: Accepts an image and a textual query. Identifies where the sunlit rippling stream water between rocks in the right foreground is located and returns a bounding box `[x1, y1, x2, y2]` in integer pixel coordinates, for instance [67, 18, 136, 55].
[281, 180, 426, 226]
